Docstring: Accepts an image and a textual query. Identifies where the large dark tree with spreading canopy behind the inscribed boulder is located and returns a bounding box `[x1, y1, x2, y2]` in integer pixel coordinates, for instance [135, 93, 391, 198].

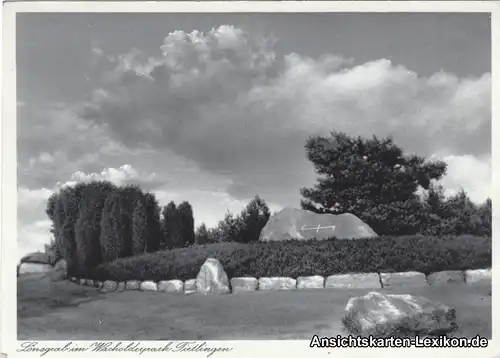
[301, 132, 447, 235]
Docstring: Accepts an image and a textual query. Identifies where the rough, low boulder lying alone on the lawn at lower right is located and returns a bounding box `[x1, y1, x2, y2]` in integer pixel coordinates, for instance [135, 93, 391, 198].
[342, 292, 456, 337]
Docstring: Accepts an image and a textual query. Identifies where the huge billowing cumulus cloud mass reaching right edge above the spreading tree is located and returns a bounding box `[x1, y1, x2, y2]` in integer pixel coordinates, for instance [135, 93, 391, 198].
[74, 26, 491, 205]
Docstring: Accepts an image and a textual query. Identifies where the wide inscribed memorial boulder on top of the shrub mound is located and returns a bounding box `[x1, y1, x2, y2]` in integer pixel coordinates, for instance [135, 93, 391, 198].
[259, 208, 377, 241]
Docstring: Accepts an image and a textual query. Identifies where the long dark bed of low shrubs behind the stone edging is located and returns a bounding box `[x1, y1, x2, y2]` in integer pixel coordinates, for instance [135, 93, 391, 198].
[86, 236, 492, 281]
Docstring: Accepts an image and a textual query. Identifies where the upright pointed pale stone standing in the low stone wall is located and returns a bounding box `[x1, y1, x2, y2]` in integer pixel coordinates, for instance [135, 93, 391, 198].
[196, 257, 231, 294]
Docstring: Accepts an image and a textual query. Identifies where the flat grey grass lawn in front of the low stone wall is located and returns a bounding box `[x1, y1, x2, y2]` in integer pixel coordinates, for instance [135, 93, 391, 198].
[18, 275, 491, 340]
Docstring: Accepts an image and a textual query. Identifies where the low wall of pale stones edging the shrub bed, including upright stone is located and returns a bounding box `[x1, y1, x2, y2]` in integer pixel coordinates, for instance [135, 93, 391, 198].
[66, 258, 491, 294]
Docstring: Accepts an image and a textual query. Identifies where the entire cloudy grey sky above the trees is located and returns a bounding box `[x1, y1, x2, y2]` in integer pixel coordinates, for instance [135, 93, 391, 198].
[17, 13, 491, 255]
